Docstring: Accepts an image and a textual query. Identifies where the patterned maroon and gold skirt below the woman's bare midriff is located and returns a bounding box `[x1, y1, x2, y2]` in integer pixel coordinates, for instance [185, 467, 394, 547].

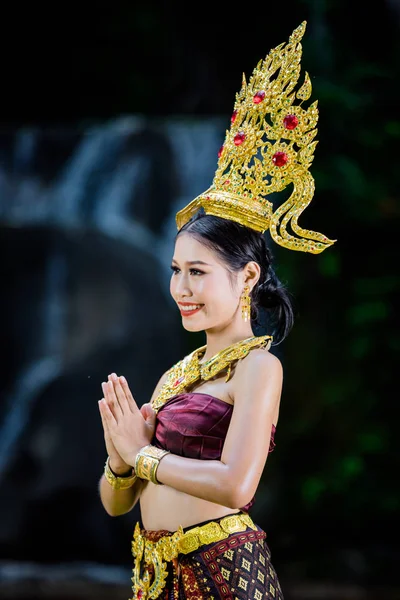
[132, 513, 283, 600]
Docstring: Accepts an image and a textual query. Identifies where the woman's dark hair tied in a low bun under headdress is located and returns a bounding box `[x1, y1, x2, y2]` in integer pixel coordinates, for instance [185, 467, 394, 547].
[175, 213, 294, 345]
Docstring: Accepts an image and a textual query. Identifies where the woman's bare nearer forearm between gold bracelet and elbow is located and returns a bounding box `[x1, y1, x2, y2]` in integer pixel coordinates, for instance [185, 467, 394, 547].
[157, 454, 240, 508]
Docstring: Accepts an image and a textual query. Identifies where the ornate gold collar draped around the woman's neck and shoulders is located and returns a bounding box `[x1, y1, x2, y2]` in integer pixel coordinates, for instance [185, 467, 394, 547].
[152, 335, 273, 412]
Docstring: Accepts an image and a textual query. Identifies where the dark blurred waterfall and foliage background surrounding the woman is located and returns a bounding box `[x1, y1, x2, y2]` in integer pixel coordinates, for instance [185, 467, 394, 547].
[0, 0, 400, 600]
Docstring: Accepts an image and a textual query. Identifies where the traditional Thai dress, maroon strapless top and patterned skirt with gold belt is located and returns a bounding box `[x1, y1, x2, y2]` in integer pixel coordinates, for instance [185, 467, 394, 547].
[132, 392, 283, 600]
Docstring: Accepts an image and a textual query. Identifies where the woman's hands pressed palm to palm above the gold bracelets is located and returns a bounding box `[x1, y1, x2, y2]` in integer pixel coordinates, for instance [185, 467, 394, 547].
[99, 373, 156, 466]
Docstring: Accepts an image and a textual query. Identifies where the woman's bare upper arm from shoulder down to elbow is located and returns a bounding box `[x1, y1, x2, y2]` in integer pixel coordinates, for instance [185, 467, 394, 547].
[221, 350, 283, 506]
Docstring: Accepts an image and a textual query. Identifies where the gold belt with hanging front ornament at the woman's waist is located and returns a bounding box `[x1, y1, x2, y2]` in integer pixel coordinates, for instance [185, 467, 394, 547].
[132, 513, 257, 600]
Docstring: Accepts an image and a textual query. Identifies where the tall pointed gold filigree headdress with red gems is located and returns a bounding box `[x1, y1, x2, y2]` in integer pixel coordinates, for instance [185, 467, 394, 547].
[176, 21, 336, 254]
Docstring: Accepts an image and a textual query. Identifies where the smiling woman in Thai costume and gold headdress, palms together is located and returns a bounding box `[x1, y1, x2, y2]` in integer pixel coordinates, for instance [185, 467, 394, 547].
[99, 23, 333, 600]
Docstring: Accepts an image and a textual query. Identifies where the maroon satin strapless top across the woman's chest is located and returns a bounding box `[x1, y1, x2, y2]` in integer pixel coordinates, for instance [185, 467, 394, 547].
[151, 392, 275, 512]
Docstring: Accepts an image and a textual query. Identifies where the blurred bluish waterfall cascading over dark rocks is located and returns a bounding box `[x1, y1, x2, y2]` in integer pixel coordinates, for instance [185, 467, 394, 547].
[0, 116, 223, 488]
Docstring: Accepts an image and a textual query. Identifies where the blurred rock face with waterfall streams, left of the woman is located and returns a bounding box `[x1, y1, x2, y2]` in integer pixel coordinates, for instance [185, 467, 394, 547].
[0, 119, 219, 566]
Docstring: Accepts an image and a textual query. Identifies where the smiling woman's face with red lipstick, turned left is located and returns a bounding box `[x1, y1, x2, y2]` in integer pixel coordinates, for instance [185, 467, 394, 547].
[170, 233, 242, 331]
